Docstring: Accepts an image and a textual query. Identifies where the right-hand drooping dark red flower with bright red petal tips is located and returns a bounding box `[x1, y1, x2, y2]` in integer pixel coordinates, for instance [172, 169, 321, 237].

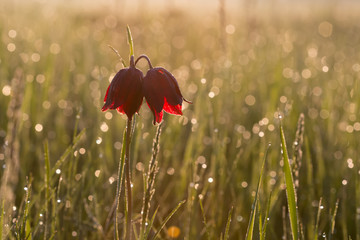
[143, 67, 188, 124]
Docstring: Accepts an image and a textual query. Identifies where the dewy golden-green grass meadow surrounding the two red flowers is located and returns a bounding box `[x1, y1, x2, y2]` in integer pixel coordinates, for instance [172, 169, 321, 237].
[0, 1, 360, 240]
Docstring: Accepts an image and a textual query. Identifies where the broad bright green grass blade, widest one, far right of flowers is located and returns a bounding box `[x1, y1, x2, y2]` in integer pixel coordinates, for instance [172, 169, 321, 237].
[280, 123, 299, 240]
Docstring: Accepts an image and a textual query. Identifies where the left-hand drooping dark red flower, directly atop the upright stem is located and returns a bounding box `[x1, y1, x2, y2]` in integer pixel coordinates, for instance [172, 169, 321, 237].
[101, 57, 144, 119]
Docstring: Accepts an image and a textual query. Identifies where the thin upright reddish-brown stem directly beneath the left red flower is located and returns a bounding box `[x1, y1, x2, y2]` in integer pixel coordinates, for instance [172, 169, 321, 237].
[125, 118, 132, 240]
